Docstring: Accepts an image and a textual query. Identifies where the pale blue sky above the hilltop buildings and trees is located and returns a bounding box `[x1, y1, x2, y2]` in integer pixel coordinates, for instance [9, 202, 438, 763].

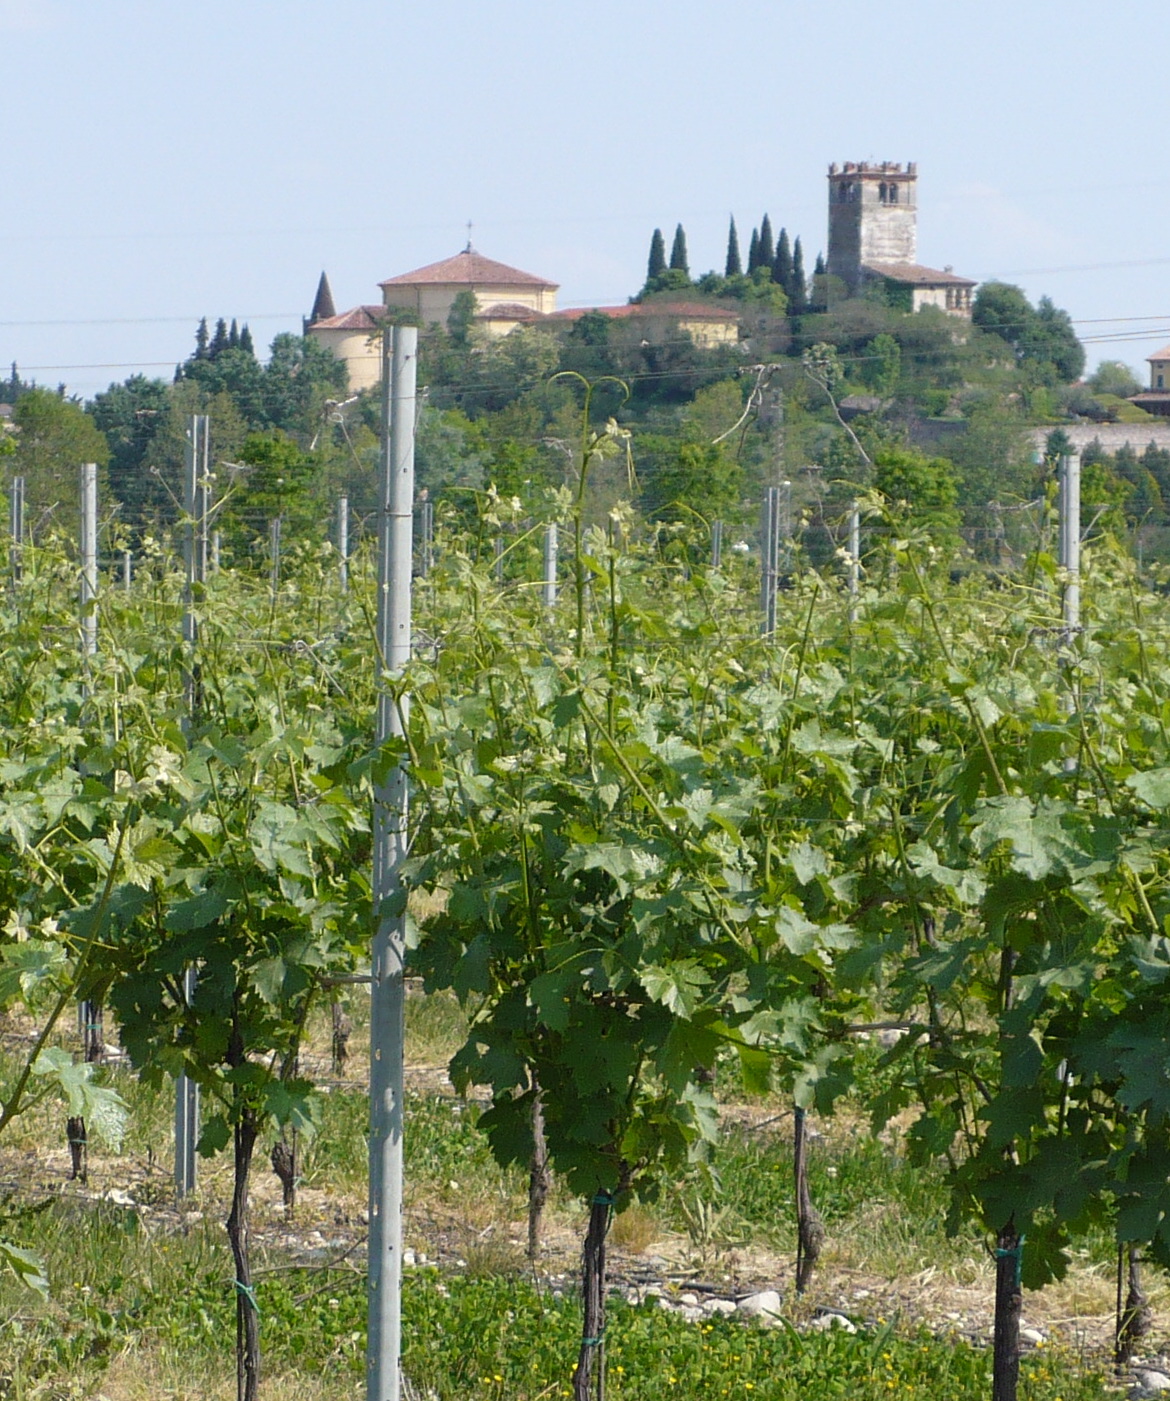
[0, 0, 1170, 395]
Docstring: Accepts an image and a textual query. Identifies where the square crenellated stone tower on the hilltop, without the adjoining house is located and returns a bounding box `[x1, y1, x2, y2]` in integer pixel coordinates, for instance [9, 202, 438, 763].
[828, 161, 918, 296]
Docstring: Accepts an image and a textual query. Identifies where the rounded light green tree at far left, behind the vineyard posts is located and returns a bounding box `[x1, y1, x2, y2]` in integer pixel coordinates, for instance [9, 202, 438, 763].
[6, 389, 109, 534]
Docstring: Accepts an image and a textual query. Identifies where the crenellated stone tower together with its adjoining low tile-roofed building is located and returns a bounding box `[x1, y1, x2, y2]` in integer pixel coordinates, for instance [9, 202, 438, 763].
[827, 161, 977, 317]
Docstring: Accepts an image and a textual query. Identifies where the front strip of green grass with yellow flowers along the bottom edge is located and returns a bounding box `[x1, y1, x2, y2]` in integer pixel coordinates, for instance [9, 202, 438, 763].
[0, 1238, 1101, 1401]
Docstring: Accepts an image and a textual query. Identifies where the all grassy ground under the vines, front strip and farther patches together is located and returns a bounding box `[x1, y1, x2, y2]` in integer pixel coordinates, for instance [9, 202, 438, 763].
[0, 999, 1132, 1401]
